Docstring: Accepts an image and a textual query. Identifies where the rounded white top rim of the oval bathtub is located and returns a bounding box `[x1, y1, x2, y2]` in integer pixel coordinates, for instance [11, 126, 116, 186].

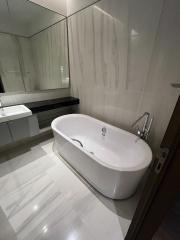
[51, 114, 153, 172]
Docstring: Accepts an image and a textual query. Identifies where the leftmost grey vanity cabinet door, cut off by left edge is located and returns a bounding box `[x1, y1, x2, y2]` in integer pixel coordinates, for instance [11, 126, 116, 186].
[0, 123, 12, 146]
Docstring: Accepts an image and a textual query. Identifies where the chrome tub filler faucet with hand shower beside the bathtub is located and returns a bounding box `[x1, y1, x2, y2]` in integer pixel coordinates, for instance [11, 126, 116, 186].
[132, 112, 153, 140]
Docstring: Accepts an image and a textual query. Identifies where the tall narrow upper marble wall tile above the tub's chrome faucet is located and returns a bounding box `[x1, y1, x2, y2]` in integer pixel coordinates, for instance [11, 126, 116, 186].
[127, 0, 164, 90]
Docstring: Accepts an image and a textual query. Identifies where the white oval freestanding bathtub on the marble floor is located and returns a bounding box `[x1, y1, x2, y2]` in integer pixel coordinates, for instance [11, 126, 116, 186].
[52, 114, 152, 199]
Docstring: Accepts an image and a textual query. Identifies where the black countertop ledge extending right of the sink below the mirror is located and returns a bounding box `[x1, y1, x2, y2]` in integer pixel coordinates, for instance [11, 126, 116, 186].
[24, 97, 79, 113]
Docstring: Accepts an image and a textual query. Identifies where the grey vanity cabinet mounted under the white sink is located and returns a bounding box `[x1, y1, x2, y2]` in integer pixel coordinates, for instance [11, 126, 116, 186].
[0, 115, 39, 146]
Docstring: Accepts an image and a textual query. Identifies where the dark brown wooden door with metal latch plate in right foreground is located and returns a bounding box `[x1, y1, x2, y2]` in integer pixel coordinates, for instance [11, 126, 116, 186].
[125, 98, 180, 240]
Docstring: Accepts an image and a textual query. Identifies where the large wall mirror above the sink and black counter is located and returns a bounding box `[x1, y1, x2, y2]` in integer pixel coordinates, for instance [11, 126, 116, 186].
[0, 0, 69, 93]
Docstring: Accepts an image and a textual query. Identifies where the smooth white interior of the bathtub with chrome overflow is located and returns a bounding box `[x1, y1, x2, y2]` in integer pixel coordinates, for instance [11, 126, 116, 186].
[54, 114, 152, 170]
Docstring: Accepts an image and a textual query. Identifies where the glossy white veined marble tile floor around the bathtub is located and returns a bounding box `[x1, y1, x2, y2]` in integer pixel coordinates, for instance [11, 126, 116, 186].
[0, 139, 139, 240]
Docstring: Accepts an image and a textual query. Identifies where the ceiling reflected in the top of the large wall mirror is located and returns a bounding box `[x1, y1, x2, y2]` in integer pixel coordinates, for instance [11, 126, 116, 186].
[0, 0, 65, 37]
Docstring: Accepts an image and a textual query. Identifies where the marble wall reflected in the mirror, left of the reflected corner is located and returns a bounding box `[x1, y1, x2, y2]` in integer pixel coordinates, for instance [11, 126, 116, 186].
[0, 33, 35, 92]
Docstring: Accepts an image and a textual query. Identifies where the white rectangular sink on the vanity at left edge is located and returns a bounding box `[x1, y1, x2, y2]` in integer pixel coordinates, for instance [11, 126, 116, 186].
[0, 105, 32, 123]
